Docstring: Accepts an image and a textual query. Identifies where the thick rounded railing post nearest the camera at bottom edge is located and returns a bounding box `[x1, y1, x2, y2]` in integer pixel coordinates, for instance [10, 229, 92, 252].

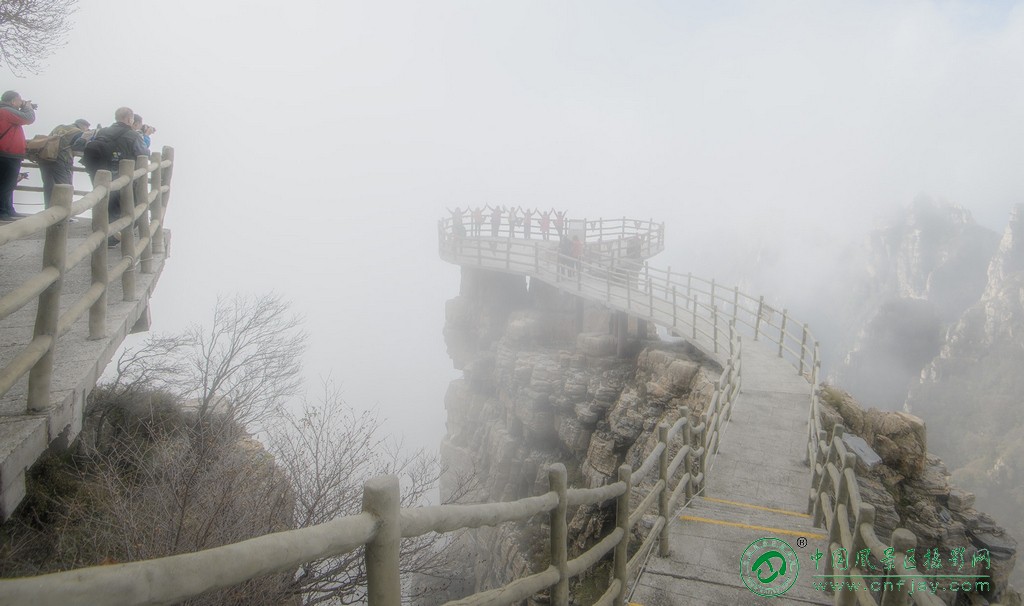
[362, 476, 401, 606]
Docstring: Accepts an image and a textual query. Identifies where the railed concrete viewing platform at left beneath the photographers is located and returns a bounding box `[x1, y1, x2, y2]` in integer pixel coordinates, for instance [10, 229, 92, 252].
[0, 147, 173, 520]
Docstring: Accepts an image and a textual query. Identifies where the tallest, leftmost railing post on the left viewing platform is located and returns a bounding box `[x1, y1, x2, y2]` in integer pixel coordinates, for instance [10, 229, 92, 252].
[28, 184, 74, 413]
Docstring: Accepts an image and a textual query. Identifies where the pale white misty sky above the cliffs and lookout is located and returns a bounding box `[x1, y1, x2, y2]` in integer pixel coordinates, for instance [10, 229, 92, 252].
[9, 0, 1024, 447]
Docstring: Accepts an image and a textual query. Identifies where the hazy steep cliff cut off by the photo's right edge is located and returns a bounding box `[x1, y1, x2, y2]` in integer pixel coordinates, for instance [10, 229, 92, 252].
[906, 206, 1024, 580]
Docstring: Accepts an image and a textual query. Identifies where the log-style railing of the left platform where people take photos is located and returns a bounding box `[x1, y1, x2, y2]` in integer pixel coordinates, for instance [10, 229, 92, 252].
[0, 147, 174, 413]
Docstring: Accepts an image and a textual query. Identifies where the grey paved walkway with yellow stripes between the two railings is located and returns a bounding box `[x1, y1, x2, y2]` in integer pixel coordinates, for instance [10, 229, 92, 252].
[632, 339, 831, 606]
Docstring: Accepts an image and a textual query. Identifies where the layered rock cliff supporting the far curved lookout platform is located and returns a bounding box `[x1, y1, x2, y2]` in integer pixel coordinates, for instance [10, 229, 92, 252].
[441, 268, 721, 590]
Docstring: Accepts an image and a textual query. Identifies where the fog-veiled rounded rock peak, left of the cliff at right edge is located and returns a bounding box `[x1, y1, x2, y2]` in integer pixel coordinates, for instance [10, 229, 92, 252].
[834, 198, 997, 409]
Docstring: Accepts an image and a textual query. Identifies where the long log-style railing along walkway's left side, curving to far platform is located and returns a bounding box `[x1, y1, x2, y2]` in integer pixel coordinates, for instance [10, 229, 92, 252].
[0, 211, 817, 606]
